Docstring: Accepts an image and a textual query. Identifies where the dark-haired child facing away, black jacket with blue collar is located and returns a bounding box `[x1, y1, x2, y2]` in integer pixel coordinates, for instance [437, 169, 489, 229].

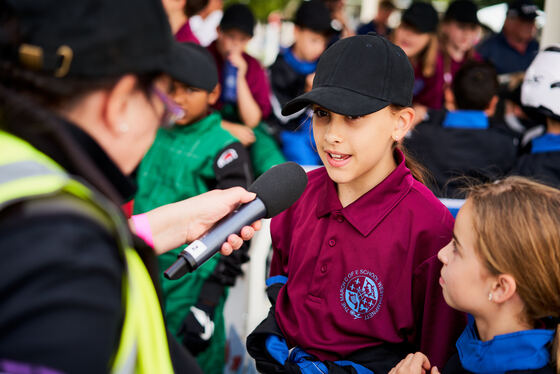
[404, 61, 519, 198]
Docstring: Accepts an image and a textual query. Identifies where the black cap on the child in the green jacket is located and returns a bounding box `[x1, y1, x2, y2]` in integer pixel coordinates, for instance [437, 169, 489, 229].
[175, 43, 218, 92]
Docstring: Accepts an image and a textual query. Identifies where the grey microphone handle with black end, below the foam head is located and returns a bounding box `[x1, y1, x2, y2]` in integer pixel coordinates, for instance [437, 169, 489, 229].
[163, 197, 266, 279]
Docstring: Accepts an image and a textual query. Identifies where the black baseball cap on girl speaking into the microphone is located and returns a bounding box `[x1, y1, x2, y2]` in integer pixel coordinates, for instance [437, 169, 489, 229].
[282, 33, 414, 116]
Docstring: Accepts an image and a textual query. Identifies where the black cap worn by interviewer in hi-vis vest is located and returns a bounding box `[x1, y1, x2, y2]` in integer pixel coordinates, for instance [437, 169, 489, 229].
[0, 0, 198, 79]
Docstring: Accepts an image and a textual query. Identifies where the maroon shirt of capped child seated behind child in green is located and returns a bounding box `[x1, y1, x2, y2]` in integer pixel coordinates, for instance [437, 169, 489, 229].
[207, 41, 272, 119]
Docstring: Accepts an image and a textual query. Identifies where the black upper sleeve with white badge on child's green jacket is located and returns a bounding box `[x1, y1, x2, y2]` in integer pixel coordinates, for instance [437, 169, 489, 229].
[213, 142, 253, 189]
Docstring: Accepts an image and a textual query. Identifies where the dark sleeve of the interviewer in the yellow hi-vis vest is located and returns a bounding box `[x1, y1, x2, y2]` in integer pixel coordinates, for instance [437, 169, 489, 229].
[0, 209, 123, 373]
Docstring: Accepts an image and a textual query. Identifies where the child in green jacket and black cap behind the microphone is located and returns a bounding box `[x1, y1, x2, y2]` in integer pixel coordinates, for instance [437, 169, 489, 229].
[134, 43, 252, 374]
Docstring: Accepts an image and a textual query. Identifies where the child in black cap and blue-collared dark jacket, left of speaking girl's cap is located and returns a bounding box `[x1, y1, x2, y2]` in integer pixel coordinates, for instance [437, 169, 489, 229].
[268, 0, 334, 165]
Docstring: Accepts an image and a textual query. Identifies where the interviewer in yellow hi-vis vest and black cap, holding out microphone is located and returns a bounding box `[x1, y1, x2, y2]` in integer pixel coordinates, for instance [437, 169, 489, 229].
[0, 0, 254, 373]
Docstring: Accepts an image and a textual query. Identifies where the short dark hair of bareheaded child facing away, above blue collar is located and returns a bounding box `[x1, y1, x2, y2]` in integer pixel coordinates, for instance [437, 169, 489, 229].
[451, 61, 498, 110]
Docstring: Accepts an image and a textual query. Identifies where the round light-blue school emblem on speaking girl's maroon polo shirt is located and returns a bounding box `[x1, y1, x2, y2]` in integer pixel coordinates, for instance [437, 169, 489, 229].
[340, 269, 383, 320]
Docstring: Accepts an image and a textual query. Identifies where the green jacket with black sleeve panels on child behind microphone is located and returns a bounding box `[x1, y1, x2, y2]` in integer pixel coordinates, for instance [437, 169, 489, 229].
[134, 112, 252, 374]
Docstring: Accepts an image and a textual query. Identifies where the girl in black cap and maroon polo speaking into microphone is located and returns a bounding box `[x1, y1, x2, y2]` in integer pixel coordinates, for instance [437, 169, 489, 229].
[247, 35, 465, 374]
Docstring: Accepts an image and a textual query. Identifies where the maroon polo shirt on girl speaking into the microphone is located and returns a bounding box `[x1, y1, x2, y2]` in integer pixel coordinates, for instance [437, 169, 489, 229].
[270, 151, 466, 367]
